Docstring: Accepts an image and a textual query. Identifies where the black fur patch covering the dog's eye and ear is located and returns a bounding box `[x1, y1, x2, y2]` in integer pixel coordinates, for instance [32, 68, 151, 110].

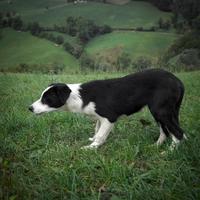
[41, 83, 71, 108]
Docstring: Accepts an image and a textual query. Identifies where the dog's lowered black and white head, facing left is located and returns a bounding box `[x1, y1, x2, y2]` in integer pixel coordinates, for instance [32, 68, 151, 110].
[29, 83, 71, 114]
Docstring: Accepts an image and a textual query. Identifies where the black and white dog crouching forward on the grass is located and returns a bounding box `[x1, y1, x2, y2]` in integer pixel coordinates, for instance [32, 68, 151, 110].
[29, 69, 184, 148]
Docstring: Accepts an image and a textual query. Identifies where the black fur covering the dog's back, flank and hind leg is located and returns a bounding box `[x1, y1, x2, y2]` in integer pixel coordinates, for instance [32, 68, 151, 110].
[80, 69, 184, 140]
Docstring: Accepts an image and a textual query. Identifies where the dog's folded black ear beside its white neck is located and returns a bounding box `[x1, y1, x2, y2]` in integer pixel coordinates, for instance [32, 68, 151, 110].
[55, 83, 71, 105]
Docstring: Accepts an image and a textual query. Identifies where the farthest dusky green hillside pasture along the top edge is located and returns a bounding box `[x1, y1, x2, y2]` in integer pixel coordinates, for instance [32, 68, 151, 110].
[0, 0, 170, 28]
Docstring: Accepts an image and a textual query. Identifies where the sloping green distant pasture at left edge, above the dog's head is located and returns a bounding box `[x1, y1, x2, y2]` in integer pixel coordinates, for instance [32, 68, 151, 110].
[0, 29, 79, 71]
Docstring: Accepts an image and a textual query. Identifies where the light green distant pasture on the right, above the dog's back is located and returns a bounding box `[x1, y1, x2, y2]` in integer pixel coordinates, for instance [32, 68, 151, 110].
[85, 32, 178, 58]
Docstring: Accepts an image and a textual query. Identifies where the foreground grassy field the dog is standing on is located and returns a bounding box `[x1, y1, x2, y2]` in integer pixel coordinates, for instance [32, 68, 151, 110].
[0, 72, 200, 200]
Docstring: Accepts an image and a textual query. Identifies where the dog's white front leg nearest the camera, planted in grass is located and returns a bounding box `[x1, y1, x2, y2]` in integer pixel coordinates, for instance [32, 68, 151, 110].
[83, 118, 114, 149]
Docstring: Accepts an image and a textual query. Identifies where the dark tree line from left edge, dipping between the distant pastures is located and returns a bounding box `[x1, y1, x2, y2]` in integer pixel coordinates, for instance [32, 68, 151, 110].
[0, 11, 112, 58]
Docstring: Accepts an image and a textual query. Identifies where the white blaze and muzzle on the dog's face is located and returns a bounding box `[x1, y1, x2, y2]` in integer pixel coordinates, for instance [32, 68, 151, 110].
[31, 86, 57, 114]
